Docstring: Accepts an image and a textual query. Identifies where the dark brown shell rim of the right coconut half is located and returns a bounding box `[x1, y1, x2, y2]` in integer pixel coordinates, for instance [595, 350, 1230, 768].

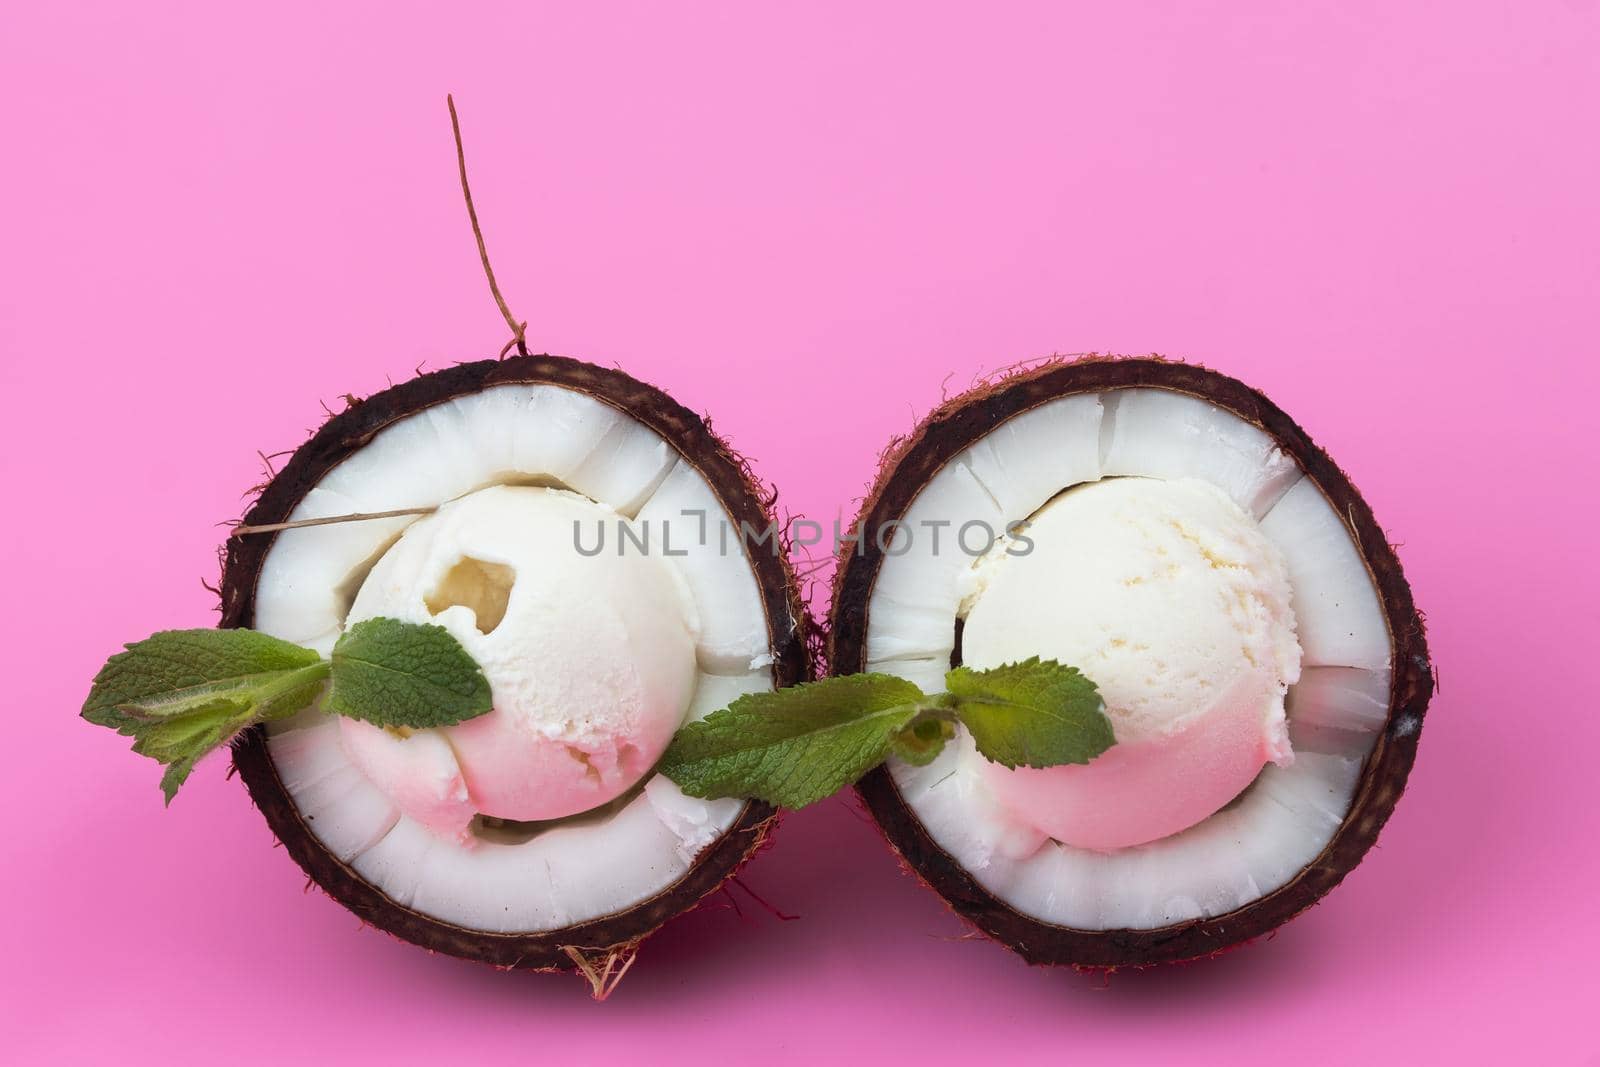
[827, 354, 1434, 968]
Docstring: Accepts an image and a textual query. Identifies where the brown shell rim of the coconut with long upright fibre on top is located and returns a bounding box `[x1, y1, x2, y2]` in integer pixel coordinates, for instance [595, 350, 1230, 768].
[218, 355, 810, 971]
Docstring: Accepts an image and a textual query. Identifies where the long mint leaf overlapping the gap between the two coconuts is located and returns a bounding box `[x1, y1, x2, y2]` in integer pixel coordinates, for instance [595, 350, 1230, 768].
[658, 673, 926, 808]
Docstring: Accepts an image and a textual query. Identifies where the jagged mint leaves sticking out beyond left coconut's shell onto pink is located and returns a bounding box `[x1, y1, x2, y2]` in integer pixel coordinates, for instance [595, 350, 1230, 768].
[82, 630, 328, 803]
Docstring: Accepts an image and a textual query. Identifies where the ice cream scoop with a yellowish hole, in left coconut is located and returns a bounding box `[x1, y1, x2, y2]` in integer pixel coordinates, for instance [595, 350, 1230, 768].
[339, 486, 698, 840]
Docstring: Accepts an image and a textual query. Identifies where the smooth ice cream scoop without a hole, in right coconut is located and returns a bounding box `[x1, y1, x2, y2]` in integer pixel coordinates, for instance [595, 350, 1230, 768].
[962, 478, 1301, 849]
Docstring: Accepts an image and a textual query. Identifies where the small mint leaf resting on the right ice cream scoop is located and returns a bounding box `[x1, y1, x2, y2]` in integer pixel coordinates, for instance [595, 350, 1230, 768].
[944, 656, 1117, 768]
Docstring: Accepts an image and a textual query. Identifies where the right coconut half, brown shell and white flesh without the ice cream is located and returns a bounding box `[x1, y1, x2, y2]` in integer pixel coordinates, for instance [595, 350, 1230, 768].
[829, 357, 1432, 966]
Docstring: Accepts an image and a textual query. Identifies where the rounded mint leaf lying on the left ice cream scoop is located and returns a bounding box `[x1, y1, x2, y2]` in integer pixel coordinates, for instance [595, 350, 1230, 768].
[326, 619, 494, 729]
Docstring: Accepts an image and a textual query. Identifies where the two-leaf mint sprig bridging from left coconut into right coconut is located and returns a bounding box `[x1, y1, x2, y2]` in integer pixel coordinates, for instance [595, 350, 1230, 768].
[658, 656, 1115, 808]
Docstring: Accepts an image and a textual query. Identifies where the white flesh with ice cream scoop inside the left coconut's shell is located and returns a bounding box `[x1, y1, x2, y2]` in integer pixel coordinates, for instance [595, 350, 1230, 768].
[254, 384, 773, 933]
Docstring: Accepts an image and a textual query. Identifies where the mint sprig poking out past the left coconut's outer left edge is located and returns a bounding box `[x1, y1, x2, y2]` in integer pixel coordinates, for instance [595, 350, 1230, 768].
[82, 619, 493, 803]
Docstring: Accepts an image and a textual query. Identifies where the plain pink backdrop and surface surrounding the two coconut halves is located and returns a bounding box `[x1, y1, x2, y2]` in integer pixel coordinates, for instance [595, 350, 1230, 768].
[0, 0, 1600, 1064]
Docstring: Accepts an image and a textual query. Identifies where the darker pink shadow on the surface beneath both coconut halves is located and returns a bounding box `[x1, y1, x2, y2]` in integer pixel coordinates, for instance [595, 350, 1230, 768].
[337, 767, 1465, 1019]
